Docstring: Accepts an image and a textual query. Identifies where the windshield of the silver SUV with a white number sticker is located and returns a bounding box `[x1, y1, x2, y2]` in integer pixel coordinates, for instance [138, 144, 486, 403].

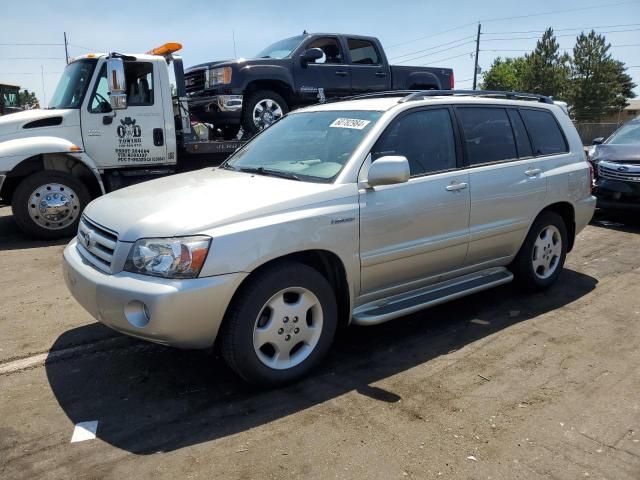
[223, 111, 382, 182]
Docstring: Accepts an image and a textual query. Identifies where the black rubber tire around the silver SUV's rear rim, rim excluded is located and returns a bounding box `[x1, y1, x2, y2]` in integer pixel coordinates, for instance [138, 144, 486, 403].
[510, 212, 569, 291]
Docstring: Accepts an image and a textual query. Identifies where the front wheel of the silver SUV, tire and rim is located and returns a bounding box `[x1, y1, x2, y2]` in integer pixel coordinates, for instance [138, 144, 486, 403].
[221, 262, 338, 387]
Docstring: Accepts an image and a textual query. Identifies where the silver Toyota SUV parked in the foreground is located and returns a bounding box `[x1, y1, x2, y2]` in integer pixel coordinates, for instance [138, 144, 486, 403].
[64, 91, 595, 385]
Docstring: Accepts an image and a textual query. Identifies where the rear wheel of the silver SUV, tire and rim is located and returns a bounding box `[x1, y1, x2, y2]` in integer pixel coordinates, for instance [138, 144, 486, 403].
[511, 212, 568, 291]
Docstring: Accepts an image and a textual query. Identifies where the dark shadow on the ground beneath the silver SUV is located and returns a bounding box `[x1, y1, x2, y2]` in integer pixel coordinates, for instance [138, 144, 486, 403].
[45, 270, 597, 455]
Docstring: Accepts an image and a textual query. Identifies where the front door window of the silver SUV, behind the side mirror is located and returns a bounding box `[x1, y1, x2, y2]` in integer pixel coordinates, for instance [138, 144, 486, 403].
[371, 107, 457, 177]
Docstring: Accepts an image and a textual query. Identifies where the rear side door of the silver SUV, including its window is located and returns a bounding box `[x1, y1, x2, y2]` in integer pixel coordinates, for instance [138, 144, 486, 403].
[455, 105, 547, 267]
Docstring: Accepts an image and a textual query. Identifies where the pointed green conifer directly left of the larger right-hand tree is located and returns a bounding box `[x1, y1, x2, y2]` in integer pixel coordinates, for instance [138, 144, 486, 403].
[521, 28, 571, 98]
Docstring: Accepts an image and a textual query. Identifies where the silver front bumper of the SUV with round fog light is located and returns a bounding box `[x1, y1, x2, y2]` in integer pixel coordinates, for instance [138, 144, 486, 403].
[63, 239, 247, 348]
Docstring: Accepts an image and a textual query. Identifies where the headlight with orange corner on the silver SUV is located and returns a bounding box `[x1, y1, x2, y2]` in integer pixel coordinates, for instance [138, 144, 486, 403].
[124, 235, 211, 278]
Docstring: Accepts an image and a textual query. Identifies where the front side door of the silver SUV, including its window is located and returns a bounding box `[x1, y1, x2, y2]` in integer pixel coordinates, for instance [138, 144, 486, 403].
[359, 107, 470, 300]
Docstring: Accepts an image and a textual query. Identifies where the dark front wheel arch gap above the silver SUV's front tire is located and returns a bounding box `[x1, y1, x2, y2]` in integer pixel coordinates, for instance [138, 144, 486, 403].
[223, 249, 351, 338]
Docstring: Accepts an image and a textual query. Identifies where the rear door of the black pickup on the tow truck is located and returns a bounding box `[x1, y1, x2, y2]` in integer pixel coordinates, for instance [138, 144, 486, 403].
[346, 37, 391, 95]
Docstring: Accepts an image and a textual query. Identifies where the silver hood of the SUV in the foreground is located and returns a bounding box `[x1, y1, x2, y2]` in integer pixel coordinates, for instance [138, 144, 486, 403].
[84, 168, 357, 242]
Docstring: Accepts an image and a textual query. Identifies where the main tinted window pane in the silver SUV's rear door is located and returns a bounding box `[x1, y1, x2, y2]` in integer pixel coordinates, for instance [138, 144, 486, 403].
[456, 107, 518, 165]
